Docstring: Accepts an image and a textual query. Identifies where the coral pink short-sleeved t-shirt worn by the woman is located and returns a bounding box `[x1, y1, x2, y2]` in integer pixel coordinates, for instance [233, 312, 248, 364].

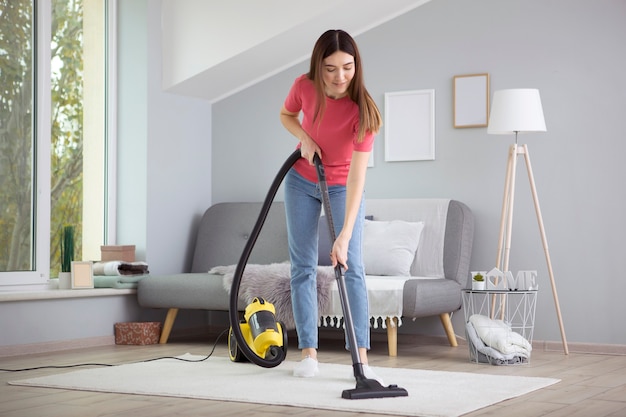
[285, 74, 374, 185]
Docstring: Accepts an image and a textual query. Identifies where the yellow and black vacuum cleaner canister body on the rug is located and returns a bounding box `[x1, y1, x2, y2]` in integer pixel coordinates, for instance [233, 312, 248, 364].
[228, 297, 287, 362]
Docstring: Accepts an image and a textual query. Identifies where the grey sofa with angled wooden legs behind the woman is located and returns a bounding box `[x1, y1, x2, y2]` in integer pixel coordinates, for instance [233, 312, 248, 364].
[137, 199, 474, 356]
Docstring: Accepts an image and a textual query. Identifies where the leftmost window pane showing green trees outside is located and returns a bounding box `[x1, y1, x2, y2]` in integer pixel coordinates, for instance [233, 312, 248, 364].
[0, 0, 35, 271]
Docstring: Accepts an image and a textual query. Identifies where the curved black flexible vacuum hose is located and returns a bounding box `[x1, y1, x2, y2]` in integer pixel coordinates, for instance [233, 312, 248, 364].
[228, 149, 302, 368]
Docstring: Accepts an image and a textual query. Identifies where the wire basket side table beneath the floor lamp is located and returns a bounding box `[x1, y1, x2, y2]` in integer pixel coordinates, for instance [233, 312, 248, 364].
[462, 289, 537, 364]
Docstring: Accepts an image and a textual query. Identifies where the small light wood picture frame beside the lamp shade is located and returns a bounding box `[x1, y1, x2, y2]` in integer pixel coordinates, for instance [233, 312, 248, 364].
[453, 73, 489, 128]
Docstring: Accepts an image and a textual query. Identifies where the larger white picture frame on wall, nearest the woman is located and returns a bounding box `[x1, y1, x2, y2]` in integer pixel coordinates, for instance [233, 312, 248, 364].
[384, 89, 435, 162]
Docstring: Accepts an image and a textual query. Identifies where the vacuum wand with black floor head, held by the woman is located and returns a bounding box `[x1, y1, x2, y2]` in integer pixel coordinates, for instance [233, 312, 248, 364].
[313, 154, 409, 400]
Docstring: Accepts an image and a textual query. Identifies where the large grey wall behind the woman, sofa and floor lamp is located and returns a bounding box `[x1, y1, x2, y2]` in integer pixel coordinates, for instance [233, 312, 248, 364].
[212, 0, 626, 344]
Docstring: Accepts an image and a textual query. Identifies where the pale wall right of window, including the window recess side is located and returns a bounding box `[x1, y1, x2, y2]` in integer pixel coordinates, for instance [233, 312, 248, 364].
[117, 0, 212, 274]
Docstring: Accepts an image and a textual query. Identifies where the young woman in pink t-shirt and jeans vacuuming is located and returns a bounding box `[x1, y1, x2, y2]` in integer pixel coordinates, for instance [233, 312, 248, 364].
[280, 30, 382, 379]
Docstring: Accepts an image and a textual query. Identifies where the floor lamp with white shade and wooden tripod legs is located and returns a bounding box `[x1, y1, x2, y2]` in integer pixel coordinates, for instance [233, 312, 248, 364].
[487, 89, 569, 355]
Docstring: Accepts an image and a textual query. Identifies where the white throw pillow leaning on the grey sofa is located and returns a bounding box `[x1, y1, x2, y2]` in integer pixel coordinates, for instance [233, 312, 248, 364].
[363, 220, 424, 276]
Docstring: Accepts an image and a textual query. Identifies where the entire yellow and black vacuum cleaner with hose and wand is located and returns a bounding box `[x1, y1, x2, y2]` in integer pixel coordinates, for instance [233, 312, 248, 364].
[229, 149, 408, 400]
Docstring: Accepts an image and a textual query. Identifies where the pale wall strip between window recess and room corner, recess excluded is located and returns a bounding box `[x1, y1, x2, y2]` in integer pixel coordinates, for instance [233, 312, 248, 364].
[146, 1, 212, 273]
